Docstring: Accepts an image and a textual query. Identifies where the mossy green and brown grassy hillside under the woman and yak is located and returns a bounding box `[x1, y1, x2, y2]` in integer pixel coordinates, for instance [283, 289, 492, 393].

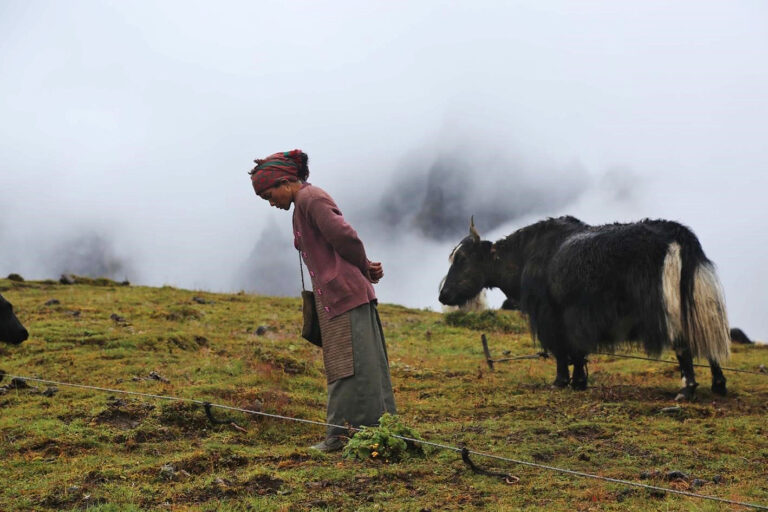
[0, 279, 768, 511]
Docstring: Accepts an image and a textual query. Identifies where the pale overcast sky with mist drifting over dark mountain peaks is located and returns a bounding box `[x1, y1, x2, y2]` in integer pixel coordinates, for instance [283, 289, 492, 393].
[0, 0, 768, 340]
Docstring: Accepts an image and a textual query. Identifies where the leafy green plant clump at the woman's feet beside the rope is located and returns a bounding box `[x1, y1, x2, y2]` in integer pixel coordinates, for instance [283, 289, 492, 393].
[342, 413, 424, 462]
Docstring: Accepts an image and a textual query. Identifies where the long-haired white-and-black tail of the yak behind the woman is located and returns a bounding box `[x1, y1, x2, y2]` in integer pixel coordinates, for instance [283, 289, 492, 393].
[662, 240, 731, 363]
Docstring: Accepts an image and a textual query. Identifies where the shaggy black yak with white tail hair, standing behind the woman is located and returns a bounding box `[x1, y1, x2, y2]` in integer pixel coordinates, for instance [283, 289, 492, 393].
[440, 216, 730, 399]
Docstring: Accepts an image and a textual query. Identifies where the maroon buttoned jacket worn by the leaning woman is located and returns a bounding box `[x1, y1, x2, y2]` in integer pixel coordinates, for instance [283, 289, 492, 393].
[293, 183, 376, 318]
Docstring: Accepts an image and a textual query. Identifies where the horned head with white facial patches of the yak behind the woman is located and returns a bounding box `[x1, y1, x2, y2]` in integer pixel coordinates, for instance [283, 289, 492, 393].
[440, 218, 493, 306]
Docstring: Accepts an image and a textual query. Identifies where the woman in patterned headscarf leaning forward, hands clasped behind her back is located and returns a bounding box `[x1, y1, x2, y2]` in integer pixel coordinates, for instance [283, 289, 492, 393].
[250, 149, 396, 452]
